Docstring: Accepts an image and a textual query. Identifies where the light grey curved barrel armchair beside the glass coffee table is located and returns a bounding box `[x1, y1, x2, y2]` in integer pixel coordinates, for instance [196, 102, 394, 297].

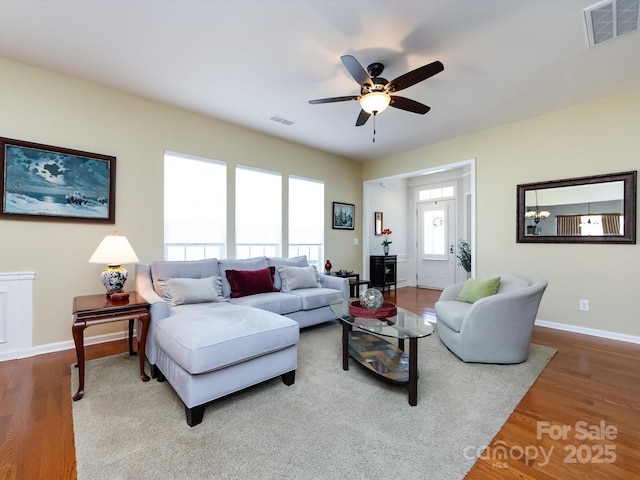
[435, 275, 547, 363]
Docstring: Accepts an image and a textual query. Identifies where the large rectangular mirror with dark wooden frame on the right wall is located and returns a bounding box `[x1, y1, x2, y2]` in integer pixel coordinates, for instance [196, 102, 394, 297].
[517, 171, 637, 243]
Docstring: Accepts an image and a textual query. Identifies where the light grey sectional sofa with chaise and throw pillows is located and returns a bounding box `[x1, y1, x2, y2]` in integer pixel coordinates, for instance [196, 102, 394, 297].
[135, 256, 349, 426]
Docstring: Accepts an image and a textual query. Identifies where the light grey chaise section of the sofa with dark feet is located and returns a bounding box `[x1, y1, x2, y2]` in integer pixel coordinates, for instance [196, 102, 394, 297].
[155, 303, 300, 426]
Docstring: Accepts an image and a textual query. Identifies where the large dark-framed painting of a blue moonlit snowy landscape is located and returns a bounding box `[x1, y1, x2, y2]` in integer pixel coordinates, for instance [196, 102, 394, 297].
[0, 137, 116, 223]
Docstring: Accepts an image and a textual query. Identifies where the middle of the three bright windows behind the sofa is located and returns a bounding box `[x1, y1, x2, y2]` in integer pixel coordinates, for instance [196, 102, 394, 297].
[236, 166, 282, 258]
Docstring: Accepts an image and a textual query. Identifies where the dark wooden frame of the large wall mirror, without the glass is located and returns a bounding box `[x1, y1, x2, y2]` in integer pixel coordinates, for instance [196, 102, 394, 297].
[516, 171, 637, 244]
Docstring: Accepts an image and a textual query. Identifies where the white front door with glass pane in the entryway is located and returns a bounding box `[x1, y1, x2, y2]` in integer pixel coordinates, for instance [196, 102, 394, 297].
[417, 200, 456, 289]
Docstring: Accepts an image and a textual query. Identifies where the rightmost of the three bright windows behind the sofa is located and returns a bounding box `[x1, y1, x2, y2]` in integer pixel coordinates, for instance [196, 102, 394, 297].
[289, 177, 324, 271]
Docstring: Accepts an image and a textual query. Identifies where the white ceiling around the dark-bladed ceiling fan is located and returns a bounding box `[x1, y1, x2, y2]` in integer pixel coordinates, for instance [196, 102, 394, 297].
[0, 0, 640, 161]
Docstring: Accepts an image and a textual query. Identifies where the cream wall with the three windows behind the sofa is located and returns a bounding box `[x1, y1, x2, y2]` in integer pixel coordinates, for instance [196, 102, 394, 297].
[0, 59, 362, 346]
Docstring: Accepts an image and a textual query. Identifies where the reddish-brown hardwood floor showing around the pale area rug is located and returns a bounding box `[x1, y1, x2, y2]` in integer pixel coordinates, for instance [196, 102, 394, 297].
[0, 288, 640, 480]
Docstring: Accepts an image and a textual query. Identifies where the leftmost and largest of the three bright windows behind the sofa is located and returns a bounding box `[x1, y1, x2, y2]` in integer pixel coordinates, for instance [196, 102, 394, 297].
[164, 152, 227, 260]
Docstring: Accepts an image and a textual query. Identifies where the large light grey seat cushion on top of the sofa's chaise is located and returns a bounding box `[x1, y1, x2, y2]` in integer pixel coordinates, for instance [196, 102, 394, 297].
[156, 303, 300, 375]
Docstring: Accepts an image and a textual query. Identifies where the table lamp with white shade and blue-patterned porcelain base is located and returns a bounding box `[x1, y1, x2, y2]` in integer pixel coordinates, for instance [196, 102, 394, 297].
[89, 232, 139, 300]
